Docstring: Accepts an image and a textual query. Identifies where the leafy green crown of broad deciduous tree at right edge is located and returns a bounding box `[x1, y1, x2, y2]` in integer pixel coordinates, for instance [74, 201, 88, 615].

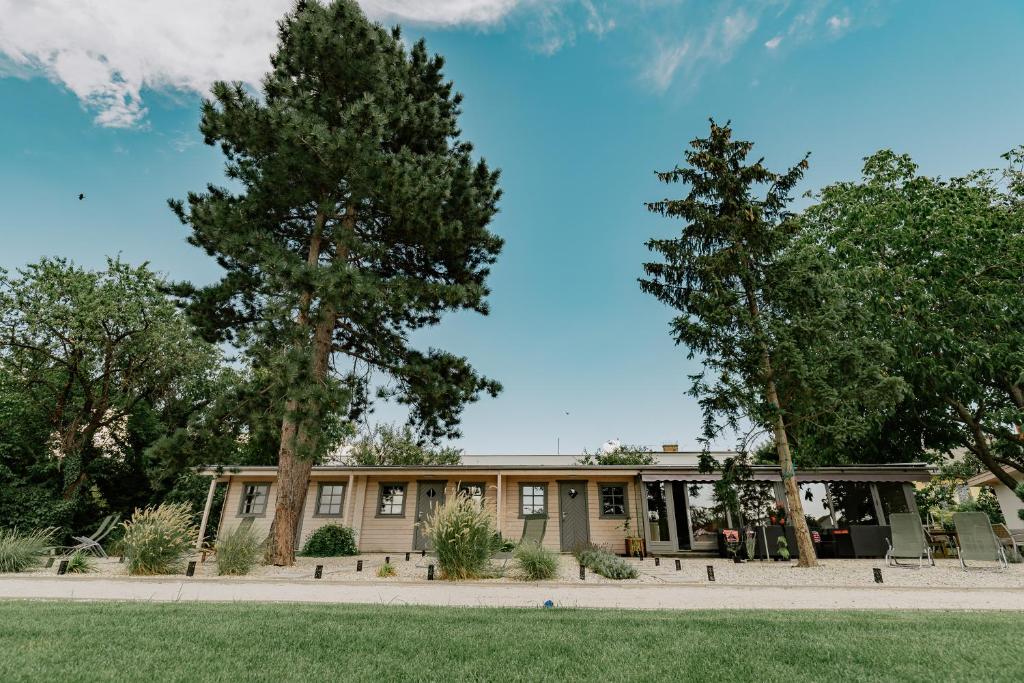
[801, 150, 1024, 487]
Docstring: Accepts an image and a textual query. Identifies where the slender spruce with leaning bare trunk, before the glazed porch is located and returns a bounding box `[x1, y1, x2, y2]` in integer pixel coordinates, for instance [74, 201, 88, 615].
[640, 121, 816, 566]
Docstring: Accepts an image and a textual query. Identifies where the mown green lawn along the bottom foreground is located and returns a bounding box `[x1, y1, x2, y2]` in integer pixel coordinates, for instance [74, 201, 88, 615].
[0, 601, 1024, 683]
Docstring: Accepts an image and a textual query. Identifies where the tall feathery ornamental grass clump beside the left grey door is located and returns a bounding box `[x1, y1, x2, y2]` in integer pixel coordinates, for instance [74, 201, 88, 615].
[422, 492, 495, 579]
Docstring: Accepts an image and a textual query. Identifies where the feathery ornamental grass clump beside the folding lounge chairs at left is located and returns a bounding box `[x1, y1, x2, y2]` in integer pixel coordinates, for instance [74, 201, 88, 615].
[121, 503, 198, 574]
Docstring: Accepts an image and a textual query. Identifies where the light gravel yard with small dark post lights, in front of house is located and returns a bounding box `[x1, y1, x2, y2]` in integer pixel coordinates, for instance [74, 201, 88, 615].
[16, 553, 1024, 588]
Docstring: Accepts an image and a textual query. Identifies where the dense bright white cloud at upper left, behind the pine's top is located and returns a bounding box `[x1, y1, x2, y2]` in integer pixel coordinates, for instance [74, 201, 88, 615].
[0, 0, 520, 128]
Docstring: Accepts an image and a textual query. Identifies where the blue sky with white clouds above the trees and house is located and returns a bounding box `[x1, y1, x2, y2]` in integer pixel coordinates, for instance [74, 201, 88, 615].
[0, 0, 1024, 454]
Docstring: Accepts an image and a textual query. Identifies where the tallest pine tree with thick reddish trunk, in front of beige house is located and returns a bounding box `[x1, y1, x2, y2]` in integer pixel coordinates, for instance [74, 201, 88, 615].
[171, 0, 502, 564]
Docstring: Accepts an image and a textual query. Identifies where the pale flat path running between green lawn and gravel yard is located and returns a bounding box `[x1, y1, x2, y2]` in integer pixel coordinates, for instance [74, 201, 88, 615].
[0, 577, 1024, 610]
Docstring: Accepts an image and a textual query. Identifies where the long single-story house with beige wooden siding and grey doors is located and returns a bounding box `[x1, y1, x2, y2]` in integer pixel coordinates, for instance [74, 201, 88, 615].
[193, 445, 931, 556]
